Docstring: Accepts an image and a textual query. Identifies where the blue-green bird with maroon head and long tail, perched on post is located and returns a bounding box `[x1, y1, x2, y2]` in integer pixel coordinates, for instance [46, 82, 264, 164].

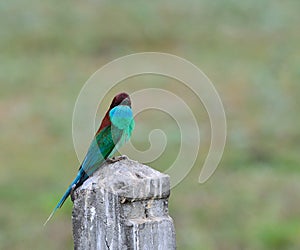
[44, 92, 135, 226]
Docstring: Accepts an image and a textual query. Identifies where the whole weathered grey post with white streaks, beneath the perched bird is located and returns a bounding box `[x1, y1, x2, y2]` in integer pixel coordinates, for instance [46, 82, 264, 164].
[72, 157, 176, 250]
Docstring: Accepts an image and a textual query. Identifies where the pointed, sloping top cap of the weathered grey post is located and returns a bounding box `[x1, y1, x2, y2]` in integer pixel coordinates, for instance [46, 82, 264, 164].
[75, 156, 170, 202]
